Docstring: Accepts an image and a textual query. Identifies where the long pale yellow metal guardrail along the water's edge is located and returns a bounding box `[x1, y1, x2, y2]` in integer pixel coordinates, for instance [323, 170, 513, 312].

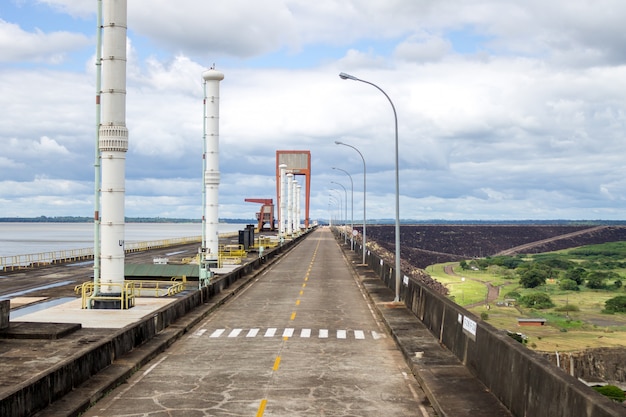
[0, 236, 202, 271]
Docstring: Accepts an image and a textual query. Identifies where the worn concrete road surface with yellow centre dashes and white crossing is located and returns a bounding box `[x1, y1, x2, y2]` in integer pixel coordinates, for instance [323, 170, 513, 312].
[84, 228, 435, 417]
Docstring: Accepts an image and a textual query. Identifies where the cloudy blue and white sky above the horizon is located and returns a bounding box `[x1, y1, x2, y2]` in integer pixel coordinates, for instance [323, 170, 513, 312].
[0, 0, 626, 223]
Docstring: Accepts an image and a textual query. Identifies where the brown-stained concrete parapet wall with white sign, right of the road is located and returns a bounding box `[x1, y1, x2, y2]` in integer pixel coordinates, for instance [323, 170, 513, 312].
[348, 237, 626, 417]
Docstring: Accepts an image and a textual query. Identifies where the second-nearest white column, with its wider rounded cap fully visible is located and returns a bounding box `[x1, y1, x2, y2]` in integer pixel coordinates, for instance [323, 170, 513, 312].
[201, 68, 224, 268]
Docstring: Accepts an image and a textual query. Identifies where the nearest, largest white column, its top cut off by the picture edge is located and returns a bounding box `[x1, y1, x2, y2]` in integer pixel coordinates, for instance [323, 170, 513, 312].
[97, 0, 128, 300]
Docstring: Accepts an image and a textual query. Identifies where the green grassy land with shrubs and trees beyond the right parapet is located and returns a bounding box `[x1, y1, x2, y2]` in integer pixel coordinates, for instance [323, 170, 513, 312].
[427, 242, 626, 352]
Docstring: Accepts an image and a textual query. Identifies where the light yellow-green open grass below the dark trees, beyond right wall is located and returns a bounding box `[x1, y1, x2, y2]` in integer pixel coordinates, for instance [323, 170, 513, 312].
[426, 263, 626, 352]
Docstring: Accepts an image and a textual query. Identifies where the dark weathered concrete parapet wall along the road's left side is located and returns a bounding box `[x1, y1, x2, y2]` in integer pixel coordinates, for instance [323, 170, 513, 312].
[0, 234, 307, 417]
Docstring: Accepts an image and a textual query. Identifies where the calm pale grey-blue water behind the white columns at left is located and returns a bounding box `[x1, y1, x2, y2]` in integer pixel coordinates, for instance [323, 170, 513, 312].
[0, 222, 246, 257]
